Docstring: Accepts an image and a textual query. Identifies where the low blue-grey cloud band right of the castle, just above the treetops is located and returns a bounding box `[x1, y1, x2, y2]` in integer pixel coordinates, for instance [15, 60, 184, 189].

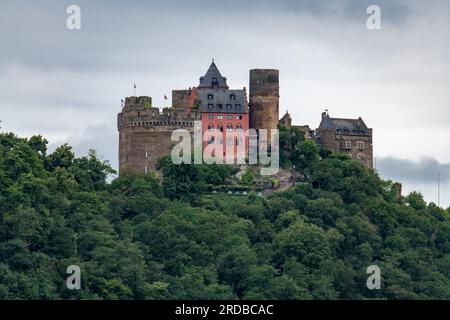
[377, 157, 450, 183]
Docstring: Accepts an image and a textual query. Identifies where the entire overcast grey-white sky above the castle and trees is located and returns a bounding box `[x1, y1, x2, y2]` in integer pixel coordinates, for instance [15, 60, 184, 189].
[0, 0, 450, 206]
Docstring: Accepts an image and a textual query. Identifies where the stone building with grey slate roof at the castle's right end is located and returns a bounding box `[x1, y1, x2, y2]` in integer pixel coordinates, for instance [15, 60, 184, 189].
[315, 112, 373, 169]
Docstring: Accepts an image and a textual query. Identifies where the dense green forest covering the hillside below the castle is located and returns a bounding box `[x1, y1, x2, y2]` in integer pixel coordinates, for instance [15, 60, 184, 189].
[0, 131, 450, 299]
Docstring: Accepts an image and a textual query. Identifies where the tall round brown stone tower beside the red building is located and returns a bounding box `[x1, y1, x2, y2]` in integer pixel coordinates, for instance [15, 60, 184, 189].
[250, 69, 280, 133]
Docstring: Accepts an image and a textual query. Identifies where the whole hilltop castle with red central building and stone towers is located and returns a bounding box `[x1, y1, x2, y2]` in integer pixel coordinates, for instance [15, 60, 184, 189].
[117, 60, 373, 175]
